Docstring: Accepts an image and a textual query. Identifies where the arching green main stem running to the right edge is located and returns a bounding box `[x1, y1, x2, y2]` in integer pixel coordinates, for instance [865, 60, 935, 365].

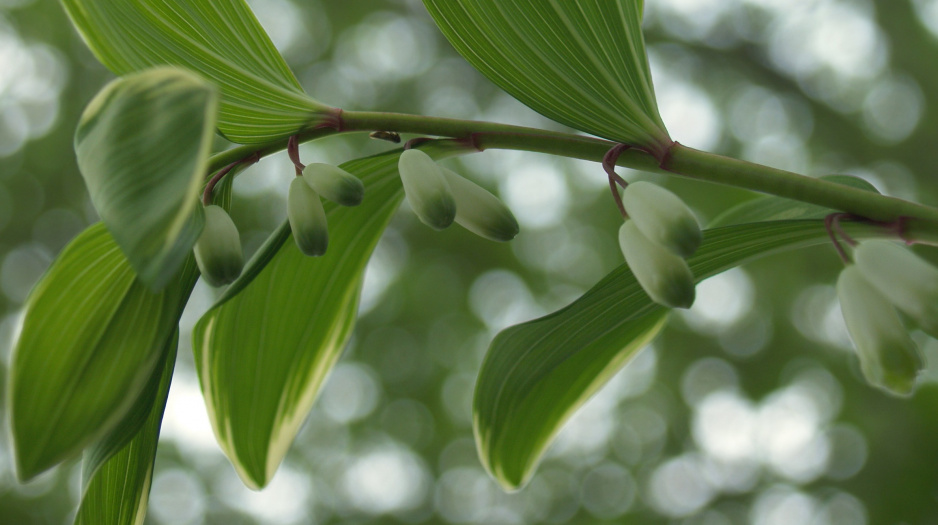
[209, 111, 938, 237]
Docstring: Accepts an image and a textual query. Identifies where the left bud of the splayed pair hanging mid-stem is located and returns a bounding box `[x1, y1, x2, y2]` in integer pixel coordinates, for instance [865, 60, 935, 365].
[397, 149, 456, 230]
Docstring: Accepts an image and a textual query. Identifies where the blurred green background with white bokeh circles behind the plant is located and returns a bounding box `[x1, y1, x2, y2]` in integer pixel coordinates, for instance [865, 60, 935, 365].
[0, 0, 938, 525]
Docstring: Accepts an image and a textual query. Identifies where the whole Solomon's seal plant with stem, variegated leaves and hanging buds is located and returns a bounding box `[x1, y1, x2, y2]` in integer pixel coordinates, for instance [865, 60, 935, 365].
[7, 0, 938, 524]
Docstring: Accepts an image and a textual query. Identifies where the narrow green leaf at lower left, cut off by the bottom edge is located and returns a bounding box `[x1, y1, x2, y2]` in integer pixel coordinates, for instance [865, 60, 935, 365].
[75, 331, 179, 525]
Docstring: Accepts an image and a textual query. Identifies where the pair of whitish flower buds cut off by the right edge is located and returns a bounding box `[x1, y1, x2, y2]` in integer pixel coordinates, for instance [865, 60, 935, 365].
[837, 240, 938, 395]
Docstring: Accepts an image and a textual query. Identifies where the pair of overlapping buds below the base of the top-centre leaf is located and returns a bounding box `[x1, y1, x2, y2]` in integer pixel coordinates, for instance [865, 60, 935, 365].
[619, 181, 703, 308]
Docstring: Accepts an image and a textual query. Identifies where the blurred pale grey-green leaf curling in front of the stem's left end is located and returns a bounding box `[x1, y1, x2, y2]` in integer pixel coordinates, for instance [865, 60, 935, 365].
[75, 67, 218, 290]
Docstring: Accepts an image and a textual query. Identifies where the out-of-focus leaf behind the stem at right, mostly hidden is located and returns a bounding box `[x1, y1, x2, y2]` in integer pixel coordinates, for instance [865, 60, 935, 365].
[710, 175, 879, 228]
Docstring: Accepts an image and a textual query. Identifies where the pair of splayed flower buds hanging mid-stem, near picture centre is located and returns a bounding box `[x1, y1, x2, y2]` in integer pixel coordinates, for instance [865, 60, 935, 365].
[397, 149, 519, 242]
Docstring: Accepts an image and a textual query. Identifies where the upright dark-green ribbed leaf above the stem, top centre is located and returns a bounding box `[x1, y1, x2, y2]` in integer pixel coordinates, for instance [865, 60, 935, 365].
[424, 0, 671, 153]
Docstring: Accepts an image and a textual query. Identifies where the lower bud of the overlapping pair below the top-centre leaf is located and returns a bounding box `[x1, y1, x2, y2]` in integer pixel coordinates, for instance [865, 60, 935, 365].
[619, 221, 696, 308]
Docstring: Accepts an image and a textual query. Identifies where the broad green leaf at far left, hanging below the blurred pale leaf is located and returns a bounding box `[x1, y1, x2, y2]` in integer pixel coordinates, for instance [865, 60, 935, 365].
[9, 223, 197, 480]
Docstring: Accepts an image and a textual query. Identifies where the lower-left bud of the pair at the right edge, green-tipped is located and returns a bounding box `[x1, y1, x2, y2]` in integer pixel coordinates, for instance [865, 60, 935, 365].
[837, 265, 924, 395]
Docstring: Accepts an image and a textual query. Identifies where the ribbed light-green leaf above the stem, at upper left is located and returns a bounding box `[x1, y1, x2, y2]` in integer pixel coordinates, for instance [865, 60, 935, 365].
[62, 0, 333, 143]
